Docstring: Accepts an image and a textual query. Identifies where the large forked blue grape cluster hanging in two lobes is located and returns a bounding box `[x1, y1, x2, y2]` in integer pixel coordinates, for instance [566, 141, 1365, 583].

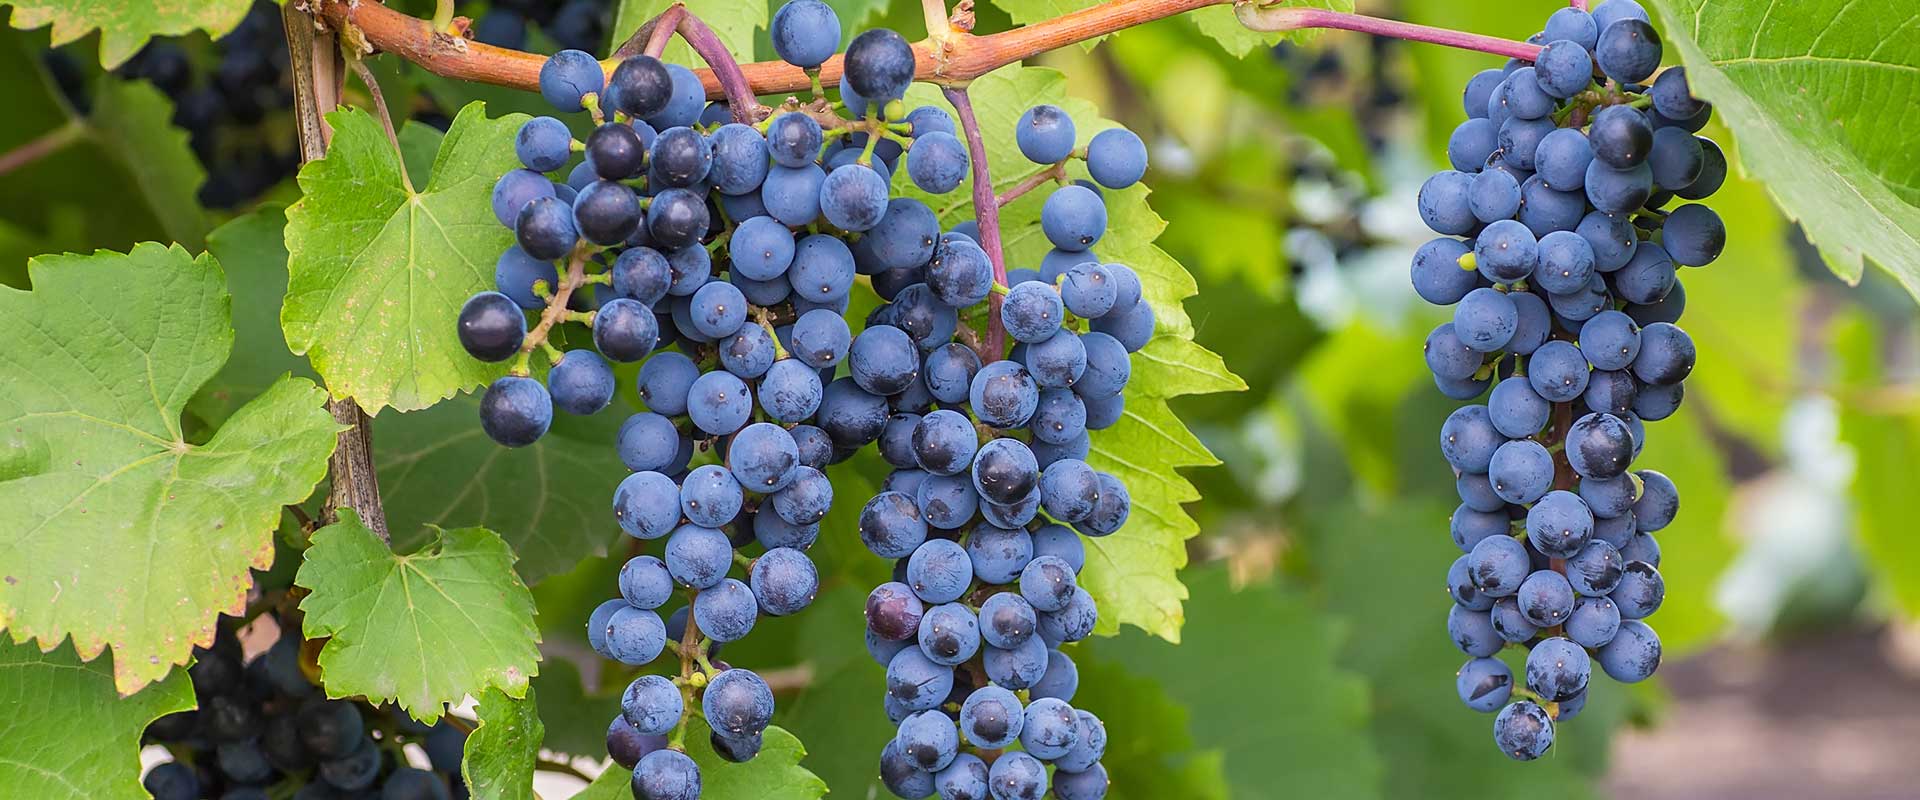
[443, 0, 1154, 800]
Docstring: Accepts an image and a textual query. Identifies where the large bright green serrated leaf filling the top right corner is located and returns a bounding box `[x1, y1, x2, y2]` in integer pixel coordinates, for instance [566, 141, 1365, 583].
[1653, 0, 1920, 297]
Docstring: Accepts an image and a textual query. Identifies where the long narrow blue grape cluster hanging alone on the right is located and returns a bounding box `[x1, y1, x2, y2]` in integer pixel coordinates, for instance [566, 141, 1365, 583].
[1413, 0, 1726, 760]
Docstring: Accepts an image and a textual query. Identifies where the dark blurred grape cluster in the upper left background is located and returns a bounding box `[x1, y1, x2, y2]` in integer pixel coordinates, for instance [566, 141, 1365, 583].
[117, 0, 300, 209]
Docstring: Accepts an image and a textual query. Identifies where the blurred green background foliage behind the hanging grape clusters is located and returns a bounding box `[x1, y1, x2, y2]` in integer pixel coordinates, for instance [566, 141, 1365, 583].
[15, 0, 1920, 798]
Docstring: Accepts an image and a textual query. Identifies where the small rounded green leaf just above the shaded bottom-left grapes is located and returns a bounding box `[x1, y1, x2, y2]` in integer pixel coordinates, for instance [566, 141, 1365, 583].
[294, 510, 540, 723]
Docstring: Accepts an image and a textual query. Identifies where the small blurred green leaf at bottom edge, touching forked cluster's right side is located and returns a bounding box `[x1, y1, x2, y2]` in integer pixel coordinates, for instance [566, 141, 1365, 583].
[1069, 643, 1233, 800]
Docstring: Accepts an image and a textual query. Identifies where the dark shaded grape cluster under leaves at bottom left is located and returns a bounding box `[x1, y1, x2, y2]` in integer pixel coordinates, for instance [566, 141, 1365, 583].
[142, 620, 467, 800]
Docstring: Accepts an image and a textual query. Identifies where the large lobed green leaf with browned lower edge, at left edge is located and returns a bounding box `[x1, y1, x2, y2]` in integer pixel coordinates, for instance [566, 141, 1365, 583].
[0, 244, 340, 694]
